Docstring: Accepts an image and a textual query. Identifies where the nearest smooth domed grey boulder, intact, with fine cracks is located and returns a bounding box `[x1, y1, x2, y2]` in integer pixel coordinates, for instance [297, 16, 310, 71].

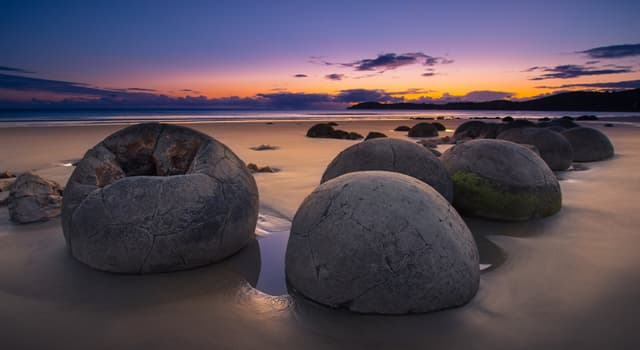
[285, 170, 480, 314]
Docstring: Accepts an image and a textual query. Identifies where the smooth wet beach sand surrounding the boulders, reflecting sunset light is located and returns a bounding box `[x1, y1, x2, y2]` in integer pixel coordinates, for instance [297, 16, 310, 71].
[0, 120, 640, 349]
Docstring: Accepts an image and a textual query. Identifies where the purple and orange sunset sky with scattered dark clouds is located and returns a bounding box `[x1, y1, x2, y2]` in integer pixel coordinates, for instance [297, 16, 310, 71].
[0, 0, 640, 109]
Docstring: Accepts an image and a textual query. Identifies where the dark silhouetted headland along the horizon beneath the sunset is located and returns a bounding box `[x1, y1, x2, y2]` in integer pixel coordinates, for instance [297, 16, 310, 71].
[349, 88, 640, 112]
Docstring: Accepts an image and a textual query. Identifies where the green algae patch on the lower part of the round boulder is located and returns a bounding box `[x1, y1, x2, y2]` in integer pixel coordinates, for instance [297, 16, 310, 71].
[452, 171, 562, 220]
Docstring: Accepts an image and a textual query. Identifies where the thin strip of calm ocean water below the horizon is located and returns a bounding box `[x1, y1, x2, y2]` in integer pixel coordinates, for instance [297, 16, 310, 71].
[0, 109, 638, 127]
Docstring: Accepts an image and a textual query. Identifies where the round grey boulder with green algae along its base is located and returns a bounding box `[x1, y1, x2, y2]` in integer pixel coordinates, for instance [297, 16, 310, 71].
[440, 140, 562, 221]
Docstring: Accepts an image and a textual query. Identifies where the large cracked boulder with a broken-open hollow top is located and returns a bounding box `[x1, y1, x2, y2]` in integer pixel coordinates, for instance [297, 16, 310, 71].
[62, 123, 258, 273]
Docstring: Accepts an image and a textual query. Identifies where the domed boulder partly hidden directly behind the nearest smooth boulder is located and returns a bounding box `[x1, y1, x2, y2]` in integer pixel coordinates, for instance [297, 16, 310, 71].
[320, 138, 453, 202]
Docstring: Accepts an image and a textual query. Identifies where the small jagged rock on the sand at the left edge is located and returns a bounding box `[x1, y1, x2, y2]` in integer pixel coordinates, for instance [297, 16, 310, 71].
[8, 173, 62, 224]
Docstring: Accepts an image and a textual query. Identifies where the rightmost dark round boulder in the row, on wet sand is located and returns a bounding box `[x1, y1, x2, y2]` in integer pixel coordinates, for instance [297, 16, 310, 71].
[562, 126, 613, 162]
